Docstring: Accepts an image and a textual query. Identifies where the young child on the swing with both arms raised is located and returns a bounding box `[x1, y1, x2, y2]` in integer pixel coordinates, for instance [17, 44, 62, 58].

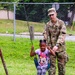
[30, 40, 55, 75]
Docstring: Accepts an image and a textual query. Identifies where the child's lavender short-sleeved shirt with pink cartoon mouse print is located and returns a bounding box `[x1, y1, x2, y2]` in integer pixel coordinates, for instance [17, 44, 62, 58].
[35, 48, 50, 67]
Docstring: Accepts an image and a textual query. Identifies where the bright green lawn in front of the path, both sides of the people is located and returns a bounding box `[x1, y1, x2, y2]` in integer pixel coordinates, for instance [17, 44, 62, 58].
[0, 36, 75, 75]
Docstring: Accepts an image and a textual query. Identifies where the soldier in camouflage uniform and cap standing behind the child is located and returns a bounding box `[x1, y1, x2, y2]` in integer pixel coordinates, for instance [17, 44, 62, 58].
[44, 8, 67, 75]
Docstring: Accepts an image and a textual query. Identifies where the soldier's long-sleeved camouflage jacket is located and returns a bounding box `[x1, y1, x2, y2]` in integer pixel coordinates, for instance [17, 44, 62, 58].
[44, 19, 66, 51]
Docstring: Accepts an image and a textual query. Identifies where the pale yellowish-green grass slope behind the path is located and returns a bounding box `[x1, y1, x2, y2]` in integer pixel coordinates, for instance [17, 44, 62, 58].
[0, 20, 75, 35]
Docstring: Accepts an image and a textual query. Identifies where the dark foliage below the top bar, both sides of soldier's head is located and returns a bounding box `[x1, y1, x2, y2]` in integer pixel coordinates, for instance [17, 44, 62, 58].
[16, 2, 74, 22]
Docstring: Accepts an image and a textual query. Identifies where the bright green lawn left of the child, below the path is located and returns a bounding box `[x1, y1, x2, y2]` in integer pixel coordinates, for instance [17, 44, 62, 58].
[0, 37, 37, 75]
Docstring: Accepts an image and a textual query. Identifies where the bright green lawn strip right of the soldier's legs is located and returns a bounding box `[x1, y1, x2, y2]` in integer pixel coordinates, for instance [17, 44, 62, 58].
[66, 42, 75, 75]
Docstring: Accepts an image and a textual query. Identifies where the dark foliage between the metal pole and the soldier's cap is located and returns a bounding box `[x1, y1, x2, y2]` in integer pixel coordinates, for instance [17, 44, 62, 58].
[16, 4, 51, 22]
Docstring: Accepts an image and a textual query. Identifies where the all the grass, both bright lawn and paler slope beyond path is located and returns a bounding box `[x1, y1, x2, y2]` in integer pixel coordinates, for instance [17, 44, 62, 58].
[0, 20, 75, 75]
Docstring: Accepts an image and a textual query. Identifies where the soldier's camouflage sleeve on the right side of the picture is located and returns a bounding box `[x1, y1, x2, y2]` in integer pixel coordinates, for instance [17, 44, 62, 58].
[56, 21, 66, 46]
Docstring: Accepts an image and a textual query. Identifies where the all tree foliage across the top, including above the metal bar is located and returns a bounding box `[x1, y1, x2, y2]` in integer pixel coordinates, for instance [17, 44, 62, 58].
[0, 0, 73, 23]
